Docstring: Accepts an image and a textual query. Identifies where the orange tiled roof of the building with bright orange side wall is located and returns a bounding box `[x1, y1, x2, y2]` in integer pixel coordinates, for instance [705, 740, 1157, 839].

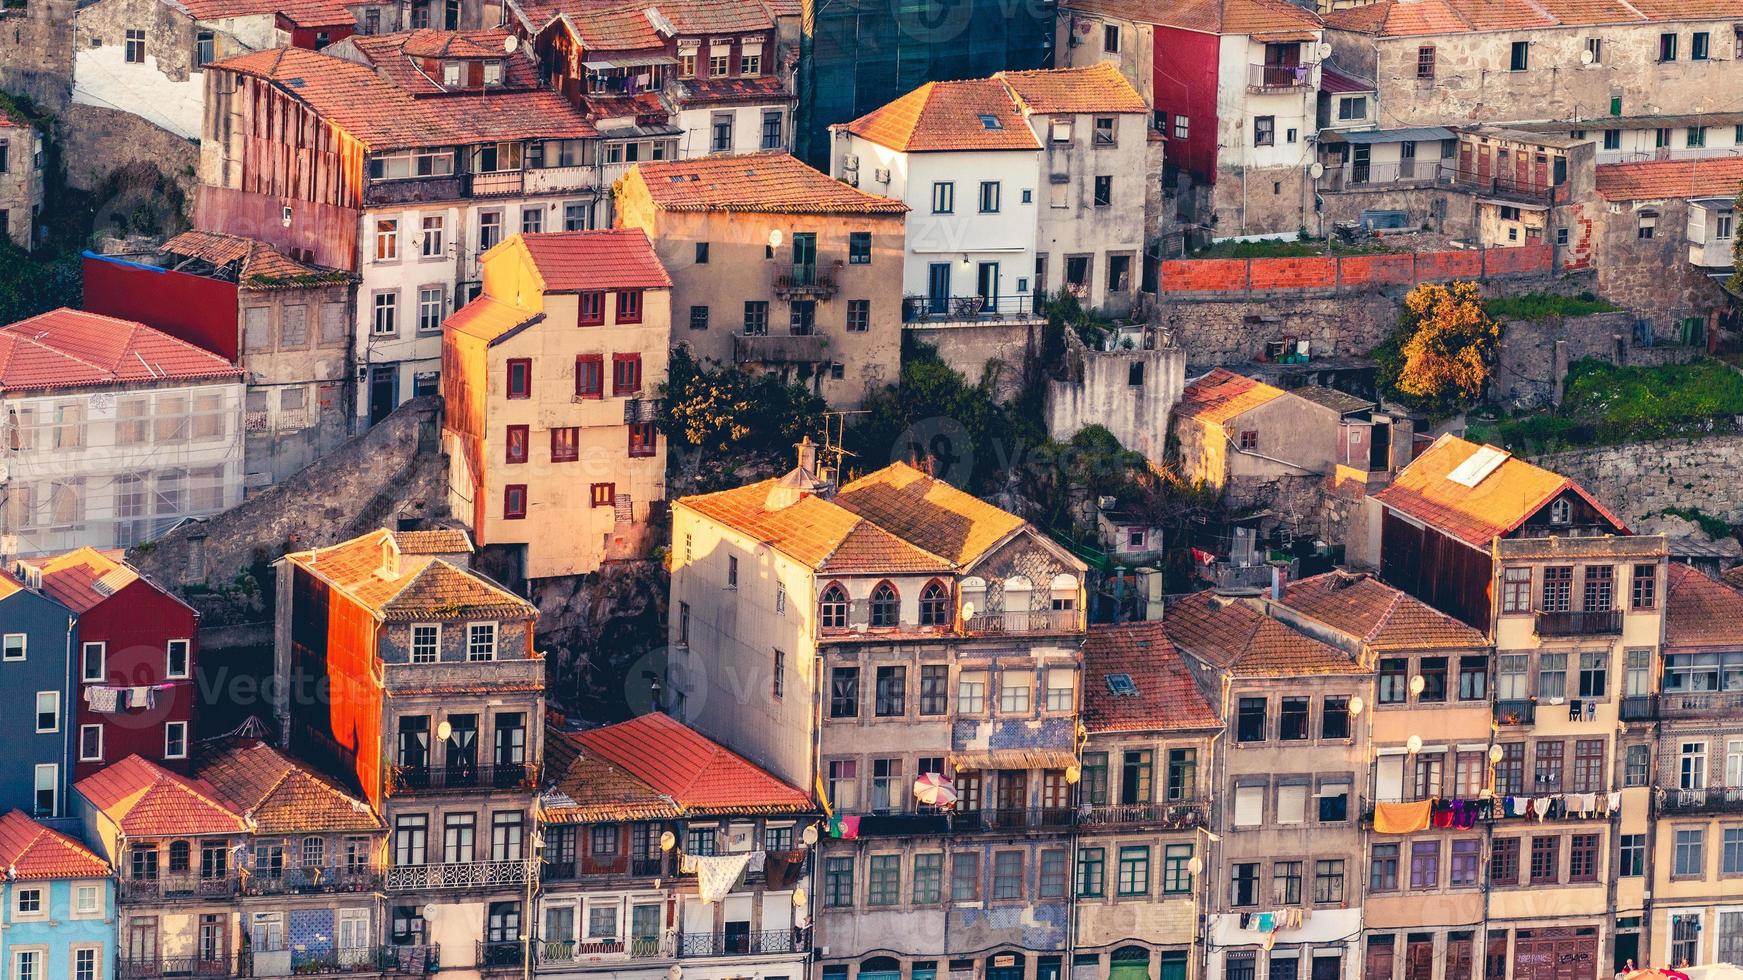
[284, 528, 539, 621]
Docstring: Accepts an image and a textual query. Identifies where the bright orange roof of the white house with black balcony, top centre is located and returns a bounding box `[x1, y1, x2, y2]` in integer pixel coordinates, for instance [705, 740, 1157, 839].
[840, 78, 1041, 153]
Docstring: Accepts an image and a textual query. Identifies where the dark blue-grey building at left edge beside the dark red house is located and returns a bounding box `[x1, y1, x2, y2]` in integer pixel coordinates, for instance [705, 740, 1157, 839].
[0, 570, 78, 818]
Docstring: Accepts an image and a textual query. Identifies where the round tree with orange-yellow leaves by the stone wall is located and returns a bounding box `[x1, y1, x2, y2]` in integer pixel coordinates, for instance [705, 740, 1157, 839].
[1373, 281, 1501, 415]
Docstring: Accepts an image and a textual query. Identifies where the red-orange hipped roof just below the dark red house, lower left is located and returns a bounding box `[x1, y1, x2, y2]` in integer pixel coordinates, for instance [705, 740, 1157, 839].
[73, 755, 248, 837]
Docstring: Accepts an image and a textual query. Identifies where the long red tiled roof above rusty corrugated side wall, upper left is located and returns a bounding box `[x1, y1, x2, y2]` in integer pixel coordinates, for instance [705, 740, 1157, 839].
[209, 47, 598, 150]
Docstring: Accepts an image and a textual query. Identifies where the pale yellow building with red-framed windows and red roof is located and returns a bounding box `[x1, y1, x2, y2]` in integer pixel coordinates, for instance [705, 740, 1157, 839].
[443, 228, 671, 579]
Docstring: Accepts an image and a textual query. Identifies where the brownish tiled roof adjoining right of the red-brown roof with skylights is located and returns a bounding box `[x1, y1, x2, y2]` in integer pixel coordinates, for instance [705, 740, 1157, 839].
[1163, 593, 1367, 677]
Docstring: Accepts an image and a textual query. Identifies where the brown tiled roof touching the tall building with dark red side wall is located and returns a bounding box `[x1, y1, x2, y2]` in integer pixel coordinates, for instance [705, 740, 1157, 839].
[1283, 572, 1487, 650]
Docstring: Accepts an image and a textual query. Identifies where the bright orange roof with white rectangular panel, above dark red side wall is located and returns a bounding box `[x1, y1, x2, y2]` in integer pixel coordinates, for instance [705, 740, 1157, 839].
[1373, 436, 1626, 551]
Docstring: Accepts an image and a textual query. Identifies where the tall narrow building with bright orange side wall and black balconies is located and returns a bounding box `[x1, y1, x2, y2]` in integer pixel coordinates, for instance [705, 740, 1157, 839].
[275, 530, 544, 971]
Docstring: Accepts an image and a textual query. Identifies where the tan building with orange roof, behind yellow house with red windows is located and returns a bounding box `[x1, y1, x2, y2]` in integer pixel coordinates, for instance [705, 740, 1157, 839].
[614, 153, 908, 408]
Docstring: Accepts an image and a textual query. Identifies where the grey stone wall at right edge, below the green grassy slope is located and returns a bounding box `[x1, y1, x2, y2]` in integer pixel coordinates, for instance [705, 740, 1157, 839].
[1532, 432, 1743, 523]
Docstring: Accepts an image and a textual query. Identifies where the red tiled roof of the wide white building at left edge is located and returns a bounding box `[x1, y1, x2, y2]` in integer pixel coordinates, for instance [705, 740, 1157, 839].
[0, 309, 242, 391]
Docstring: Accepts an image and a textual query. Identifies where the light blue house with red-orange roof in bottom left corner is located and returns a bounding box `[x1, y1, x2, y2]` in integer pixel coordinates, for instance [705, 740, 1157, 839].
[0, 802, 115, 980]
